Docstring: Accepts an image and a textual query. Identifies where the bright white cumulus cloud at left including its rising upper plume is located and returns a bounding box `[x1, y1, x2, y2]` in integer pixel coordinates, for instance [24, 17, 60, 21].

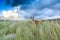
[2, 7, 24, 20]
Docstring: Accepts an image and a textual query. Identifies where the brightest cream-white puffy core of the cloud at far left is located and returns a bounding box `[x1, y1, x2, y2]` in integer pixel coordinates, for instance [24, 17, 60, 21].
[2, 10, 18, 18]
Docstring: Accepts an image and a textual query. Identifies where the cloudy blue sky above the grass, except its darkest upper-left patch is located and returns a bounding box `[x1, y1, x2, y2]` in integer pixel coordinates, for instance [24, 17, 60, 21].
[0, 0, 60, 19]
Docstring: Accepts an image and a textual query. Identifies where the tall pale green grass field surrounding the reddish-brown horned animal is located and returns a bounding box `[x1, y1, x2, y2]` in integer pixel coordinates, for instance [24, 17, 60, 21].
[0, 20, 60, 40]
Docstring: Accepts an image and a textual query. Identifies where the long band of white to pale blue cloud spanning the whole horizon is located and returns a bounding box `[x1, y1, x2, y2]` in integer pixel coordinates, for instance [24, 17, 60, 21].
[2, 4, 60, 20]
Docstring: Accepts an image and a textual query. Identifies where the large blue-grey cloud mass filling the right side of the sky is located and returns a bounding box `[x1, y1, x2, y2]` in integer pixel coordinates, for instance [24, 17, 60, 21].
[7, 0, 60, 19]
